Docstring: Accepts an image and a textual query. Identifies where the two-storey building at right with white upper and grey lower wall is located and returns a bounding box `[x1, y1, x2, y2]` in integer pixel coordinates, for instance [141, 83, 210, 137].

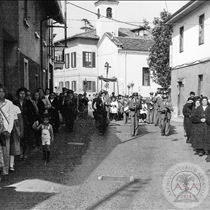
[166, 0, 210, 116]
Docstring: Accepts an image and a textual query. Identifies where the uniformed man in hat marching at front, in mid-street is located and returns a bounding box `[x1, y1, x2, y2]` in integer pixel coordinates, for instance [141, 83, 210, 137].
[128, 93, 141, 136]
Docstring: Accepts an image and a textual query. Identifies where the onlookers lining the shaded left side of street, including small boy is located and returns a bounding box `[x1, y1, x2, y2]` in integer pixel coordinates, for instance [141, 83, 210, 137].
[0, 84, 88, 180]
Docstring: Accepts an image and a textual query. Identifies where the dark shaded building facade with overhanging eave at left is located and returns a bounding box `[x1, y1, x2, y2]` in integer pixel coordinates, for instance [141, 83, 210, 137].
[0, 0, 64, 94]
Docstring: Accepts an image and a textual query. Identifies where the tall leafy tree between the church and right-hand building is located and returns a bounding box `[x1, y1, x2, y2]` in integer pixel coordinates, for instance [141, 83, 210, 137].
[148, 10, 172, 88]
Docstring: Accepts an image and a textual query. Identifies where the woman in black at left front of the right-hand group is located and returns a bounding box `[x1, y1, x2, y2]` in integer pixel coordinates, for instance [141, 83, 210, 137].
[182, 98, 194, 143]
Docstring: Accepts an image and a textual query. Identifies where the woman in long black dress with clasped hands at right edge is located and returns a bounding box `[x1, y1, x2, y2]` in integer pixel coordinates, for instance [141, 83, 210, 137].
[192, 97, 210, 162]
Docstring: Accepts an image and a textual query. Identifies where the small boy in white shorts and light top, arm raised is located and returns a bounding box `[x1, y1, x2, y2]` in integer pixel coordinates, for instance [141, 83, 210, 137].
[35, 114, 54, 162]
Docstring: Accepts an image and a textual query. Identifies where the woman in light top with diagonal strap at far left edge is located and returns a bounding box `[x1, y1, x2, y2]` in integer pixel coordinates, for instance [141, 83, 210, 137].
[0, 84, 14, 179]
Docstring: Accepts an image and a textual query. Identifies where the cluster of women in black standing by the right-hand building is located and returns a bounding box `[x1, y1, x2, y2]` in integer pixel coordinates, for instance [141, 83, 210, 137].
[183, 92, 210, 162]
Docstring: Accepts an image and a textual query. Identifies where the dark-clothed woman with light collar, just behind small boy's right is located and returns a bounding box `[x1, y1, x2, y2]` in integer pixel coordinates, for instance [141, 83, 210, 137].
[48, 92, 60, 133]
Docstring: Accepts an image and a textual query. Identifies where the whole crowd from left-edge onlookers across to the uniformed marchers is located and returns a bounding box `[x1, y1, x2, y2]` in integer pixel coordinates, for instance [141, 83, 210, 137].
[0, 84, 176, 179]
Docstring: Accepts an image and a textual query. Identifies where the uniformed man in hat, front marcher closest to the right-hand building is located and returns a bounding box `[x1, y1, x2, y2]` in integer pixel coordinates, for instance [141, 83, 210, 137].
[160, 91, 174, 136]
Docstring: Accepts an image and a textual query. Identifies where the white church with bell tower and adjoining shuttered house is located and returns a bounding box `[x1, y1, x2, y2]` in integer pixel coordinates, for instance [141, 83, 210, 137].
[54, 0, 159, 97]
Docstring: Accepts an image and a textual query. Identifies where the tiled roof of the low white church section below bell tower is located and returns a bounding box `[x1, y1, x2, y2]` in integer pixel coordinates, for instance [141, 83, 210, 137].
[107, 33, 153, 51]
